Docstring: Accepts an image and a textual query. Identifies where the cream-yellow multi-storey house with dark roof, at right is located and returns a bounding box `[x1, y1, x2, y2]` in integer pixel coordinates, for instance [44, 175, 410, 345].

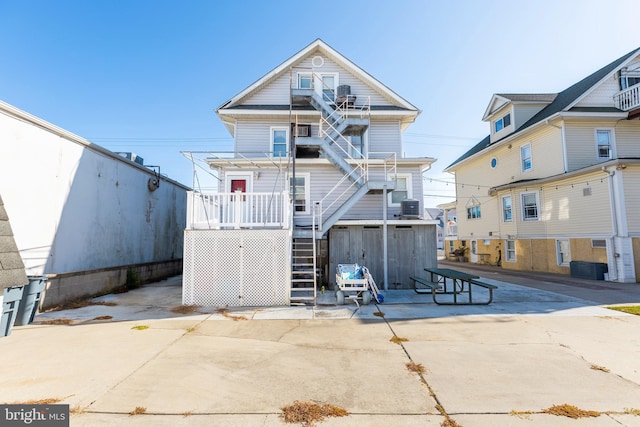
[446, 49, 640, 282]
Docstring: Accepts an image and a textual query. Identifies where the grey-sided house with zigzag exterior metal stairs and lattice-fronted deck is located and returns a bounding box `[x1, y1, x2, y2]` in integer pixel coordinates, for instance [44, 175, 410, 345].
[183, 39, 436, 305]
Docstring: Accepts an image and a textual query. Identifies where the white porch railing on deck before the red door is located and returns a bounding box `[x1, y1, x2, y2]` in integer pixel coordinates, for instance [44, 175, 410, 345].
[187, 191, 291, 230]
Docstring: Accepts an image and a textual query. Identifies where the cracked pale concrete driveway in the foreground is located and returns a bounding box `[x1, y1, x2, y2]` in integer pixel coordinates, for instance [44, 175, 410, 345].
[0, 271, 640, 427]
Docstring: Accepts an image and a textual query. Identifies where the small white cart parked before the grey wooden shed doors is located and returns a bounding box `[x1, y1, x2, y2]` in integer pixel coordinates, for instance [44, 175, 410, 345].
[336, 264, 384, 305]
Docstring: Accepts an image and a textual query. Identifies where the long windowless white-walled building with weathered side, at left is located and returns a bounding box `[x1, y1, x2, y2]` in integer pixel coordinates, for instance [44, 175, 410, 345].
[0, 102, 189, 307]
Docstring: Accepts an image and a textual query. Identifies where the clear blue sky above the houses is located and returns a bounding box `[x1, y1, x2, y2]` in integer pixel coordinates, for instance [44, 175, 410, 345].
[0, 0, 640, 207]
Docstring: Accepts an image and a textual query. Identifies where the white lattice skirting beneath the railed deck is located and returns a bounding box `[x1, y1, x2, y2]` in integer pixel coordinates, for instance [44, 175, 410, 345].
[182, 230, 291, 307]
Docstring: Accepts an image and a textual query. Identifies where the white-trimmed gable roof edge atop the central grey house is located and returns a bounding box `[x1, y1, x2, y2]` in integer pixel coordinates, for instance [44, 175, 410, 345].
[218, 39, 419, 112]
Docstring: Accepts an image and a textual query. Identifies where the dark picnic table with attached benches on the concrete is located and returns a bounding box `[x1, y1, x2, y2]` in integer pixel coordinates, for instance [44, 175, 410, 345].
[410, 268, 498, 305]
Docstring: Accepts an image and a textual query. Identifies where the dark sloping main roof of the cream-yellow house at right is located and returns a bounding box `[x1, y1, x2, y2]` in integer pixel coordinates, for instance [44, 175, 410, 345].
[445, 48, 640, 171]
